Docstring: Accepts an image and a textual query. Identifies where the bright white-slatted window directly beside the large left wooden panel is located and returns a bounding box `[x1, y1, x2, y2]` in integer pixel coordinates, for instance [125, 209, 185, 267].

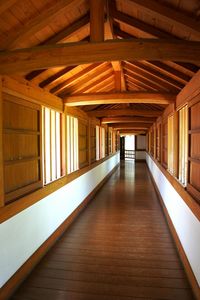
[43, 107, 61, 184]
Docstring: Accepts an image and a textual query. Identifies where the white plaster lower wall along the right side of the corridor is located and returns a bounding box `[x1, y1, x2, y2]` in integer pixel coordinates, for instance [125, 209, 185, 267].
[146, 154, 200, 286]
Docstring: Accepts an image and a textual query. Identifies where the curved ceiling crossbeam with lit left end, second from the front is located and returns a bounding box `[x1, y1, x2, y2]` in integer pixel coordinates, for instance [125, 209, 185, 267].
[64, 92, 176, 106]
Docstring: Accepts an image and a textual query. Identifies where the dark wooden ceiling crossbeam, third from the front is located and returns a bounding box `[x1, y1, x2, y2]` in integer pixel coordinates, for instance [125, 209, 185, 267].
[87, 108, 163, 118]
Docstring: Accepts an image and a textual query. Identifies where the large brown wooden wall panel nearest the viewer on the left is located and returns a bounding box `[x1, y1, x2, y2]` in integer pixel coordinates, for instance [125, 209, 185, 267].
[3, 94, 43, 203]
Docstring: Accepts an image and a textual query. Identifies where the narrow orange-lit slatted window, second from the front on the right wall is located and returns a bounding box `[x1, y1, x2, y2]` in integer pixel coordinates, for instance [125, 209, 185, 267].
[168, 115, 174, 174]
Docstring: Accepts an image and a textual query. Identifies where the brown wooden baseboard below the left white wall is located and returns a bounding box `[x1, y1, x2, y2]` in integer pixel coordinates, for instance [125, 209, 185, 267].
[0, 163, 119, 300]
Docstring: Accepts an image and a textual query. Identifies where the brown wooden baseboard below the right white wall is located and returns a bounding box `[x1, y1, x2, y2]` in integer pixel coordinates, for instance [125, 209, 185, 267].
[147, 164, 200, 300]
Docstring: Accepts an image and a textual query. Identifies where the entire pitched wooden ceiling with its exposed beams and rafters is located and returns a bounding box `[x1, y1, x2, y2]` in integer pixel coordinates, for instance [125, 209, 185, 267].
[0, 0, 200, 132]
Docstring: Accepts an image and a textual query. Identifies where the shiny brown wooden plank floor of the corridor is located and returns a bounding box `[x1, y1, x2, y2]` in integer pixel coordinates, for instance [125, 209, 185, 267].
[12, 161, 193, 300]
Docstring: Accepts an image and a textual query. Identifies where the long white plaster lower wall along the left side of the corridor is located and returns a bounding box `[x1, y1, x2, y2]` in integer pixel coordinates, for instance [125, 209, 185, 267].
[0, 153, 120, 287]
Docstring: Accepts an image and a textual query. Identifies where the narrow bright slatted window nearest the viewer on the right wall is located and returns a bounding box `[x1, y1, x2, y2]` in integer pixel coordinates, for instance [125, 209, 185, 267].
[178, 105, 188, 185]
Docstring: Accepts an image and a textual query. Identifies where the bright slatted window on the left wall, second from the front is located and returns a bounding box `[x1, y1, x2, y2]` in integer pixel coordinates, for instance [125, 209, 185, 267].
[67, 116, 79, 174]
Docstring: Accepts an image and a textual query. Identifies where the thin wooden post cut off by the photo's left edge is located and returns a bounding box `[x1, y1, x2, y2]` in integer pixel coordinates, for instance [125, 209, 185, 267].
[0, 76, 4, 207]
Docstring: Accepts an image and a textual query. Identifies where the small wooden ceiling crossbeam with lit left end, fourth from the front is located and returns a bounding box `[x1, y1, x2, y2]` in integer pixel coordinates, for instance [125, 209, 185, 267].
[101, 116, 156, 124]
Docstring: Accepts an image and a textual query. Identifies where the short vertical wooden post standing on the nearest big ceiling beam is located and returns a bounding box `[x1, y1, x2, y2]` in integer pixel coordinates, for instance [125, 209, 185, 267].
[90, 0, 105, 42]
